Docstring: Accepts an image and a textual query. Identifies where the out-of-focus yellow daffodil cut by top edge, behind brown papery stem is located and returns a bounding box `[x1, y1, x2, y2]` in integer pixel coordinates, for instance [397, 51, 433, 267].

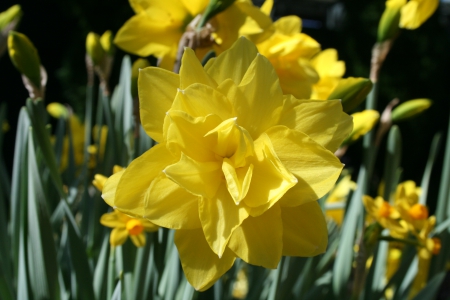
[114, 0, 271, 70]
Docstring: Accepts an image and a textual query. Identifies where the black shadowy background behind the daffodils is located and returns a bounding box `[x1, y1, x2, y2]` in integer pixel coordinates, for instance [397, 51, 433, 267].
[0, 0, 450, 208]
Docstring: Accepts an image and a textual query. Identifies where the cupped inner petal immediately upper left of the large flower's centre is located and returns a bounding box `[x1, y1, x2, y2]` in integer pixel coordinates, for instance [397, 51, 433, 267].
[164, 110, 221, 162]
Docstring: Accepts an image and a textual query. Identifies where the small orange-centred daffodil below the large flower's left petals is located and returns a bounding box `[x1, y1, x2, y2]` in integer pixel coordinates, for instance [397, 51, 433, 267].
[100, 210, 158, 247]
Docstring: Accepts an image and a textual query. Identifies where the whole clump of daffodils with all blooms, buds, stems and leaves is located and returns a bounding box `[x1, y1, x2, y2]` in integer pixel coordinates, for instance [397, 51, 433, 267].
[0, 0, 450, 300]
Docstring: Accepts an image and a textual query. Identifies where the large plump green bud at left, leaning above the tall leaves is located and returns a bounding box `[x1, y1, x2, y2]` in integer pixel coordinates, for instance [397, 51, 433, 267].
[8, 30, 41, 88]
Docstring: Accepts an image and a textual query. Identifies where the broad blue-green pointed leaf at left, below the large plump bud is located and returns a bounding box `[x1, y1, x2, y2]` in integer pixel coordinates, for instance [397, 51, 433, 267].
[27, 129, 59, 299]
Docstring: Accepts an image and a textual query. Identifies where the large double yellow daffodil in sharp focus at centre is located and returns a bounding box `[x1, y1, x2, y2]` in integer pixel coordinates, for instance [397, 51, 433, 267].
[103, 38, 352, 290]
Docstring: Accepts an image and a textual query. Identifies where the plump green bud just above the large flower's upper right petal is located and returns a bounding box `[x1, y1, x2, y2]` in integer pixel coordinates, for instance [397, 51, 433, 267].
[328, 77, 373, 112]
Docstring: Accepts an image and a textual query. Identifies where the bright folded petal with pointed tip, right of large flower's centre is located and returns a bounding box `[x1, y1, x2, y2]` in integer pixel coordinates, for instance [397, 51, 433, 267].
[244, 134, 297, 216]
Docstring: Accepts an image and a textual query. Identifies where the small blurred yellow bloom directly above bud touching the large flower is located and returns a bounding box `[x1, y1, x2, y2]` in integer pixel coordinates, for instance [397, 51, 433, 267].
[311, 49, 345, 100]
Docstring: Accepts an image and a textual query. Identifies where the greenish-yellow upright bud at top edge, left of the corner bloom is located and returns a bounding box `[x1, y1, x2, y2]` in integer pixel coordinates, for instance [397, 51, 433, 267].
[377, 0, 406, 43]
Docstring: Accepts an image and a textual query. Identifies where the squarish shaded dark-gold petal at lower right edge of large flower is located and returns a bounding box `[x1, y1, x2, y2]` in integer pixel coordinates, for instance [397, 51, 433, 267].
[281, 202, 328, 256]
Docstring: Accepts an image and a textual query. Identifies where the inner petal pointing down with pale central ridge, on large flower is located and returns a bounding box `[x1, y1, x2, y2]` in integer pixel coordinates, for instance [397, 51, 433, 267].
[199, 184, 248, 257]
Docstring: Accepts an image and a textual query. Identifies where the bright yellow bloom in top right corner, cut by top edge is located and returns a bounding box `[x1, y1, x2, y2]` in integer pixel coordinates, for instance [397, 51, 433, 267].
[399, 0, 439, 29]
